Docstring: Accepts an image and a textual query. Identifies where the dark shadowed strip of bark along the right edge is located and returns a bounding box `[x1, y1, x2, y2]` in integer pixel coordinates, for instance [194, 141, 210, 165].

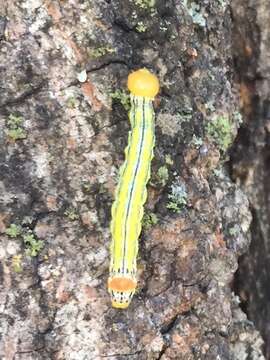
[232, 0, 270, 359]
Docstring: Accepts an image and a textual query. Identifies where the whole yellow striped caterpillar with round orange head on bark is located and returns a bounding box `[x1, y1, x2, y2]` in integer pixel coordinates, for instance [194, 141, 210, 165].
[108, 69, 159, 309]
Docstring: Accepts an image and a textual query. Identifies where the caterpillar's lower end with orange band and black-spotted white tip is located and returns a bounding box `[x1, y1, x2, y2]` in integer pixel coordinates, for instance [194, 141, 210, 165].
[108, 276, 137, 309]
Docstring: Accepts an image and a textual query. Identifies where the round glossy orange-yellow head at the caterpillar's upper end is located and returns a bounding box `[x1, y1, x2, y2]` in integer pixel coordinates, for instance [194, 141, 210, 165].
[128, 69, 159, 99]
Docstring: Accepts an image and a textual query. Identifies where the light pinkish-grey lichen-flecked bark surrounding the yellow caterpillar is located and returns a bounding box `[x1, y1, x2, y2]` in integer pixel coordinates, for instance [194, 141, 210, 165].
[0, 0, 269, 360]
